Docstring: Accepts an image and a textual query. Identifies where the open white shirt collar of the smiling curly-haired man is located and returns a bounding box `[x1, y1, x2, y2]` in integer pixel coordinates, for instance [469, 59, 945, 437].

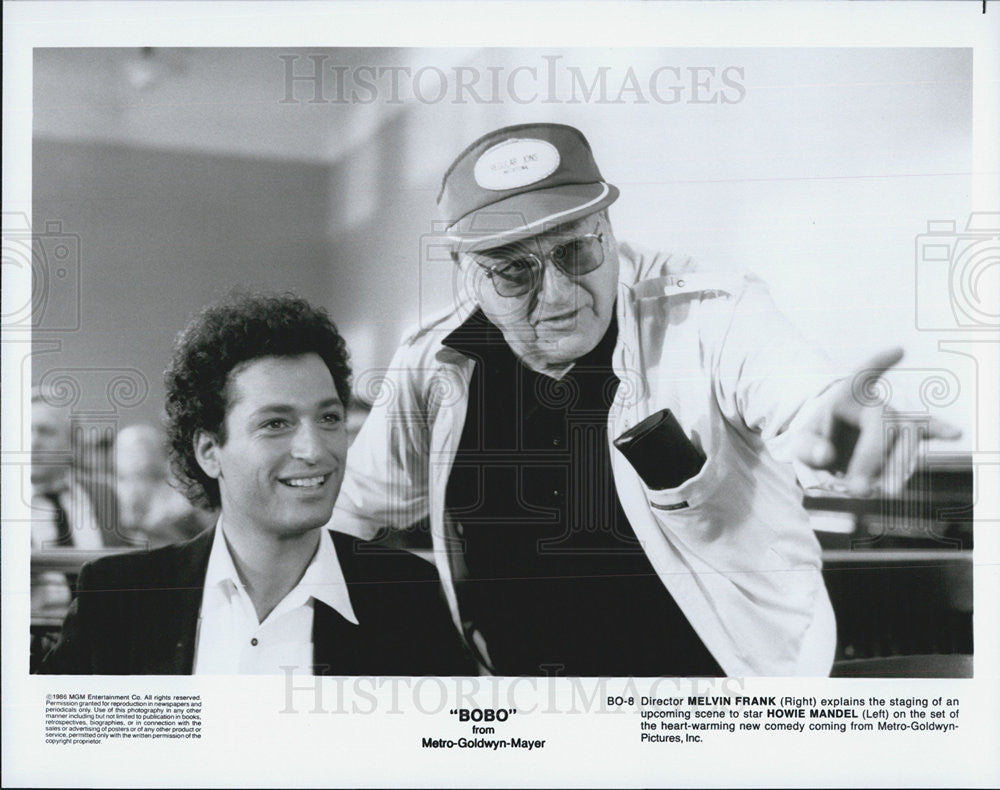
[203, 516, 359, 625]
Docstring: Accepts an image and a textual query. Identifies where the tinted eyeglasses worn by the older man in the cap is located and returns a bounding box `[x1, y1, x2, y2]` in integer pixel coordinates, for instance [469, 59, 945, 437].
[476, 224, 604, 297]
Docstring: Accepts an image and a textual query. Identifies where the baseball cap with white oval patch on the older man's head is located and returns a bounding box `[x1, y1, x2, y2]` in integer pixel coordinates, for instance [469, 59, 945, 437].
[437, 123, 618, 251]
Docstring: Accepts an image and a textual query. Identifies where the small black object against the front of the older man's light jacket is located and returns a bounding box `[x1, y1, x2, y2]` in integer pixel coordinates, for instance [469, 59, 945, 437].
[615, 409, 705, 491]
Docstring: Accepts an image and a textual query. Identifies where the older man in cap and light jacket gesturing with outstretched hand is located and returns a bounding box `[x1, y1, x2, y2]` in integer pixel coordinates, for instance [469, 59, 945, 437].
[333, 124, 956, 676]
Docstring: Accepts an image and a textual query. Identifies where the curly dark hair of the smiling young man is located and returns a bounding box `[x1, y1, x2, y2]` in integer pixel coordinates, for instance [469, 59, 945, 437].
[163, 293, 351, 509]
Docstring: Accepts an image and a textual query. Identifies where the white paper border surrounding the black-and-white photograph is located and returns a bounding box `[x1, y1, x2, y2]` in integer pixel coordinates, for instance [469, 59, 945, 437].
[0, 2, 1000, 787]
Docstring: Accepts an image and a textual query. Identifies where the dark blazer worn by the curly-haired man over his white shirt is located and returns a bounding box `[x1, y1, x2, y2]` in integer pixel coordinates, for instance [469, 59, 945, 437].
[39, 529, 476, 676]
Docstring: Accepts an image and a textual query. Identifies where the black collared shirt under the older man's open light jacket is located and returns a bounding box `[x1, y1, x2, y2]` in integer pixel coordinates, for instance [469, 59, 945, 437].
[445, 311, 724, 676]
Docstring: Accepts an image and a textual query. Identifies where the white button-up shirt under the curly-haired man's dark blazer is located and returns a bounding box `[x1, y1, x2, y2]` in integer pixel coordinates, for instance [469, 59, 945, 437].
[194, 518, 358, 675]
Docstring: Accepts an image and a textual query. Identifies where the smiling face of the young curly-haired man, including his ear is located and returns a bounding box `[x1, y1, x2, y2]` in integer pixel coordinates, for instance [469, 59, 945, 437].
[195, 354, 348, 538]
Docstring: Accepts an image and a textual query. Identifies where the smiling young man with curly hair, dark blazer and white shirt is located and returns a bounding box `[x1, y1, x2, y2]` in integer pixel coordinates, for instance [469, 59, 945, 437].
[41, 295, 469, 675]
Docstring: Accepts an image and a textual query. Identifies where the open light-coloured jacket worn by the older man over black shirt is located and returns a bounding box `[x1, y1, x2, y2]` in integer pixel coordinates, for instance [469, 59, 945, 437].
[331, 244, 836, 676]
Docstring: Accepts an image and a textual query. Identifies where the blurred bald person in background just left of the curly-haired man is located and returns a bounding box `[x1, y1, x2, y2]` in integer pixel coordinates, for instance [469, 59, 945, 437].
[114, 424, 215, 548]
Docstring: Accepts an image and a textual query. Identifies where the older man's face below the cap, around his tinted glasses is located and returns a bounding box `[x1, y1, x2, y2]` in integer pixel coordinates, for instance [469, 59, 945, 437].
[460, 214, 618, 372]
